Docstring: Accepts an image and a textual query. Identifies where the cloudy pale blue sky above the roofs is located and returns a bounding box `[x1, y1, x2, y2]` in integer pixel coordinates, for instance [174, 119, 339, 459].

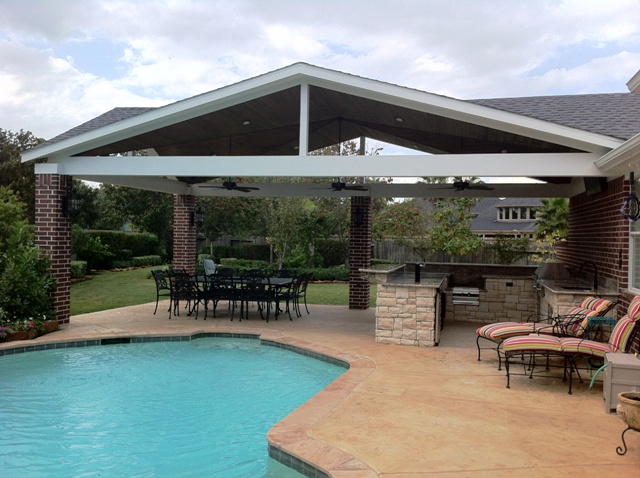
[0, 0, 640, 139]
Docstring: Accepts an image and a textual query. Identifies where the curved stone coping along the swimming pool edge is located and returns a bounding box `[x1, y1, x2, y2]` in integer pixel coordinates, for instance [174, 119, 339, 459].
[0, 330, 378, 478]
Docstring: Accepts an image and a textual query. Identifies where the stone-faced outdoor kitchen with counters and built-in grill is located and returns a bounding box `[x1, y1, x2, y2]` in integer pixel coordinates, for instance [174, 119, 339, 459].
[361, 263, 618, 347]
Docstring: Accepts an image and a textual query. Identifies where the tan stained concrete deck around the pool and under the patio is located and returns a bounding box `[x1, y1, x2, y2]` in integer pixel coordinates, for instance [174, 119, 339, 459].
[0, 302, 640, 478]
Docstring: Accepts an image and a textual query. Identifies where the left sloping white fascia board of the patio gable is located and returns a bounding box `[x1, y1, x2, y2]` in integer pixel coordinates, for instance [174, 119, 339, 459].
[22, 66, 308, 162]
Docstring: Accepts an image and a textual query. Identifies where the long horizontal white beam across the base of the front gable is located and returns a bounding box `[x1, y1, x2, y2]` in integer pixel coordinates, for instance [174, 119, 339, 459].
[52, 153, 605, 177]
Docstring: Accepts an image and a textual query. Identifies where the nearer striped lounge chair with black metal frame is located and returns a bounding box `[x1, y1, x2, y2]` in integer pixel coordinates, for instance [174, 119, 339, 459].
[502, 296, 640, 394]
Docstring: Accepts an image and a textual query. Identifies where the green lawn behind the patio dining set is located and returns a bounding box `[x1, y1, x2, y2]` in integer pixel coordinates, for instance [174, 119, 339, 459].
[71, 267, 376, 315]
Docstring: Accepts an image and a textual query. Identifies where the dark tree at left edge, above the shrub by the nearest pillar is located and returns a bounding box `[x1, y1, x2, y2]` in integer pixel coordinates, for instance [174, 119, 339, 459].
[0, 128, 44, 222]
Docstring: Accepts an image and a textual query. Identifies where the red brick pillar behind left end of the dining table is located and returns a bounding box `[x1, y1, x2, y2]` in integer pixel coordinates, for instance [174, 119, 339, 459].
[173, 194, 197, 274]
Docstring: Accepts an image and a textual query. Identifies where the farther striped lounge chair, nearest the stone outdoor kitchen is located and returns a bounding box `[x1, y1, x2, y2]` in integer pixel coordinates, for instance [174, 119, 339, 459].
[476, 297, 617, 370]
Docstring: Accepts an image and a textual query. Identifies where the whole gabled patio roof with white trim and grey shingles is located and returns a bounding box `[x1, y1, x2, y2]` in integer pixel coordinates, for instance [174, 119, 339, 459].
[23, 63, 640, 197]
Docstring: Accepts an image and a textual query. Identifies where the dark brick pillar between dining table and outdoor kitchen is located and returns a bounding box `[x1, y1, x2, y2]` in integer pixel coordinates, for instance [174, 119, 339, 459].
[349, 196, 371, 309]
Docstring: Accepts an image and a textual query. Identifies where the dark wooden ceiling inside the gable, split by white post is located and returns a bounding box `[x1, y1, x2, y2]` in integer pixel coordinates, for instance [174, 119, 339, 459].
[72, 86, 575, 156]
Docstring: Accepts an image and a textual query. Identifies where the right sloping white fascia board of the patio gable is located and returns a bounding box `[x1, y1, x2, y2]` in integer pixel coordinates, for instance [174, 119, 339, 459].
[307, 66, 622, 154]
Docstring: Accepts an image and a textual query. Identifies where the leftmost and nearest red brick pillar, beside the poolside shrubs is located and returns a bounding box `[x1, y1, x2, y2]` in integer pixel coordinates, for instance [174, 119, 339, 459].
[35, 174, 72, 324]
